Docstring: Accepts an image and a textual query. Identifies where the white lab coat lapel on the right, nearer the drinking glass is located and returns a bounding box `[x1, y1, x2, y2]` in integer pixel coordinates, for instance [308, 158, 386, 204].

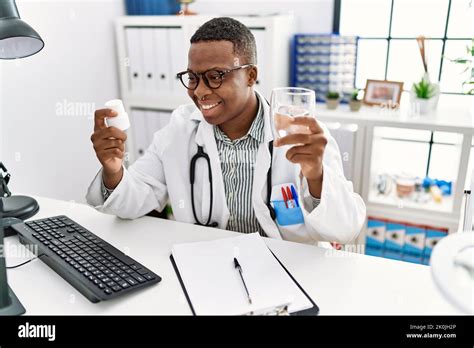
[252, 92, 282, 239]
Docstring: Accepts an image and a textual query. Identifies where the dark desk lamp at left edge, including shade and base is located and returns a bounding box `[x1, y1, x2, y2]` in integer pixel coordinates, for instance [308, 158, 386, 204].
[0, 0, 44, 315]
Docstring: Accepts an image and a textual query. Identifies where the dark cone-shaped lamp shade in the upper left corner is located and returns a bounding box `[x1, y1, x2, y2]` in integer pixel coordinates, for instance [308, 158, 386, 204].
[0, 0, 44, 59]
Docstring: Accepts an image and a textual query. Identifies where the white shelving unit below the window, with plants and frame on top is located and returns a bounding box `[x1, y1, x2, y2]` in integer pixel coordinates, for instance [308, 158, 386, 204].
[316, 104, 474, 243]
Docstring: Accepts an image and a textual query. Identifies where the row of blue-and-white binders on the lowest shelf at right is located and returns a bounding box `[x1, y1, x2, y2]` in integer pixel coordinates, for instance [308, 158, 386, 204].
[365, 217, 448, 265]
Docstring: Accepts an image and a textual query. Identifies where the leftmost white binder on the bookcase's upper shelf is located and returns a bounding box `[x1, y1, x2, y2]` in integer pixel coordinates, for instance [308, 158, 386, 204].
[125, 28, 145, 94]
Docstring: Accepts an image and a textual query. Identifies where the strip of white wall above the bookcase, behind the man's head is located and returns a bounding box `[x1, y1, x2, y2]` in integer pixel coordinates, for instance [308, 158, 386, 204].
[190, 0, 334, 34]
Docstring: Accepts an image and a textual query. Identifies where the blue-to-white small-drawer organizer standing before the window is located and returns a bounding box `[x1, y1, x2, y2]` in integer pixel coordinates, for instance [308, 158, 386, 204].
[291, 34, 357, 102]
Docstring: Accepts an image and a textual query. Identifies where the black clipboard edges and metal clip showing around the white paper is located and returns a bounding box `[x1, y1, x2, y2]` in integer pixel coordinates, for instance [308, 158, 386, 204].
[170, 234, 319, 316]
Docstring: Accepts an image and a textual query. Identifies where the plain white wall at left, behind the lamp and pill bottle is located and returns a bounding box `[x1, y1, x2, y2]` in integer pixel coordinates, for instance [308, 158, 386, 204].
[0, 0, 124, 202]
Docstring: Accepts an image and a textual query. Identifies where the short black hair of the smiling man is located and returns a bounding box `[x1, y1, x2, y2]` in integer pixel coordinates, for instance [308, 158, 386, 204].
[191, 17, 257, 64]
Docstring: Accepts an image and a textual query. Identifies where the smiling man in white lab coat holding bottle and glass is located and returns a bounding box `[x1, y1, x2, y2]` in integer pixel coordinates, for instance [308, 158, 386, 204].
[87, 18, 365, 244]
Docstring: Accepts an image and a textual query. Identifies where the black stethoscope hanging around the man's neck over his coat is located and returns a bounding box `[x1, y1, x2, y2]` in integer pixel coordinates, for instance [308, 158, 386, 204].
[189, 140, 275, 227]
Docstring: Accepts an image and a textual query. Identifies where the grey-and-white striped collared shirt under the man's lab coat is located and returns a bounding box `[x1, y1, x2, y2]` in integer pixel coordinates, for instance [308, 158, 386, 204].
[214, 100, 266, 236]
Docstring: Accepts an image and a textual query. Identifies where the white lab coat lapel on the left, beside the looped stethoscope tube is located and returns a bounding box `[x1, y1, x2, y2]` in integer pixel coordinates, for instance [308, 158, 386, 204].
[191, 110, 230, 229]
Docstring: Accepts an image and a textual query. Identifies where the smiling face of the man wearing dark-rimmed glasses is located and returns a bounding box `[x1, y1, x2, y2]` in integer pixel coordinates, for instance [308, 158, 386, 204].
[188, 40, 257, 125]
